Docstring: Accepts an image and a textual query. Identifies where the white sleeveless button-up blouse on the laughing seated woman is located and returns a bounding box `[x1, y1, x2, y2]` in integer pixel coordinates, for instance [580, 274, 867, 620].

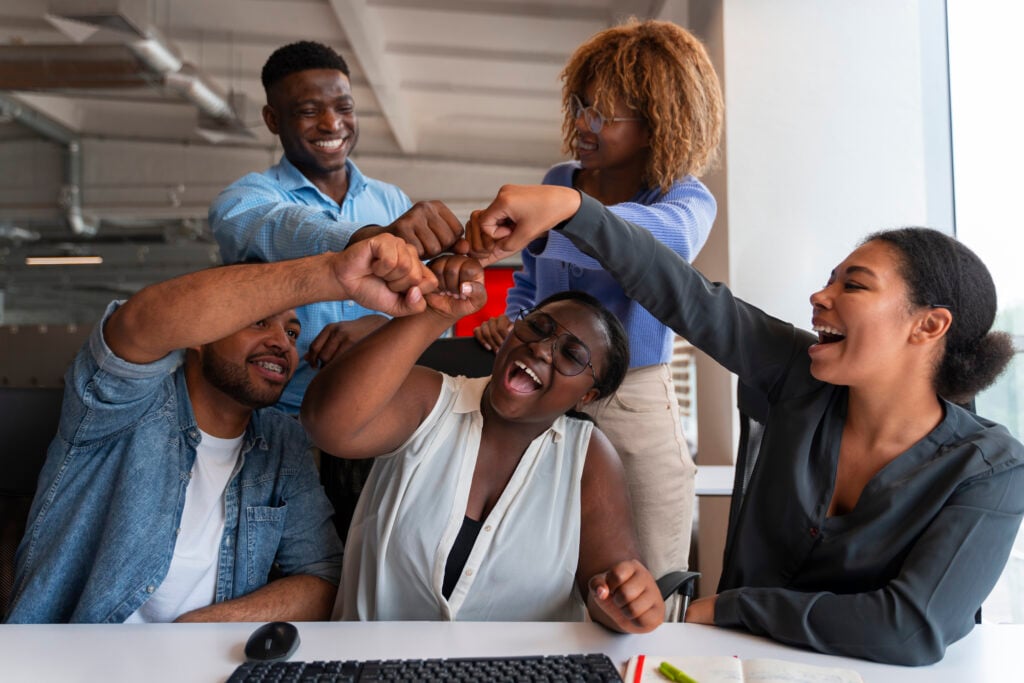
[334, 376, 593, 622]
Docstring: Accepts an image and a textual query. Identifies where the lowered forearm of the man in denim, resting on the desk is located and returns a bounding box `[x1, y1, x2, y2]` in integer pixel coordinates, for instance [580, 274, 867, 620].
[175, 575, 338, 622]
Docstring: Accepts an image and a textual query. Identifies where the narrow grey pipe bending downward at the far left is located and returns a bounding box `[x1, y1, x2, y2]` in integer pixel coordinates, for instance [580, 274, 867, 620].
[0, 92, 99, 238]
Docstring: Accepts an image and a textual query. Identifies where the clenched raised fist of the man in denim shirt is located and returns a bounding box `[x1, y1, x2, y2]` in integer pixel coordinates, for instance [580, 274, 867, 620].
[333, 234, 437, 316]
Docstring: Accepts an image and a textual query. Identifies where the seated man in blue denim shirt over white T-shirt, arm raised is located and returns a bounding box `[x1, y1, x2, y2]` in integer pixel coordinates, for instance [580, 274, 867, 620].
[7, 234, 436, 623]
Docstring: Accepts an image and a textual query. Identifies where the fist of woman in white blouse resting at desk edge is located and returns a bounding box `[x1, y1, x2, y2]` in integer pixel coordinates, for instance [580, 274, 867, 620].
[587, 560, 665, 633]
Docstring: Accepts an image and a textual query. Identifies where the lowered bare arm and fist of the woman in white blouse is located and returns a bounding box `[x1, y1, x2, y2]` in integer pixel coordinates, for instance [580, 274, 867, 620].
[577, 428, 665, 633]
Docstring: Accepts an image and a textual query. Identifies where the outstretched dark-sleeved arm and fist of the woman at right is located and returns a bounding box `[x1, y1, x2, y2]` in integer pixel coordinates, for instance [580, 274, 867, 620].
[467, 185, 812, 393]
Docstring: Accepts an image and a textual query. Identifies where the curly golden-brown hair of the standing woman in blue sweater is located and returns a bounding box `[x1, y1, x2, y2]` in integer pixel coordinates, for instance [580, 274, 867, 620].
[561, 17, 725, 191]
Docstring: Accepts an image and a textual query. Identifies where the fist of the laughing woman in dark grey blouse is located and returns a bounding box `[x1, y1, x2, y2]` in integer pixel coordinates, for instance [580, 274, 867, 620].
[463, 185, 580, 265]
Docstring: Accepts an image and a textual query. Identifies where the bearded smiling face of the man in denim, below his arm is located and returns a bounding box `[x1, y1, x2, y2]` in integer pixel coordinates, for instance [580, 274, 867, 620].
[199, 310, 301, 409]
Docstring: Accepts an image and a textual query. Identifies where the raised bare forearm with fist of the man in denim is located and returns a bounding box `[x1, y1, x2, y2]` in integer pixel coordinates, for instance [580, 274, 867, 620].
[103, 234, 436, 364]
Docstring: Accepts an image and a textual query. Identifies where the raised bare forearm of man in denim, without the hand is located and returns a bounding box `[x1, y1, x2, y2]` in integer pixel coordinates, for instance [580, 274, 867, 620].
[104, 255, 348, 362]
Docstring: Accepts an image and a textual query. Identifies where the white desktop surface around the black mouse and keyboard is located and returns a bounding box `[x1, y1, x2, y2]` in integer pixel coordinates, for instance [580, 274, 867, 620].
[0, 622, 1024, 683]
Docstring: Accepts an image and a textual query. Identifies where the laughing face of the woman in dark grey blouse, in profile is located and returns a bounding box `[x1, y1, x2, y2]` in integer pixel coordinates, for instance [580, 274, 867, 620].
[808, 241, 927, 387]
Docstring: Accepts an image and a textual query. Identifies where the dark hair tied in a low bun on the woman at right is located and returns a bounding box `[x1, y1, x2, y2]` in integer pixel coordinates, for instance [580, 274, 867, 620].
[861, 227, 1014, 403]
